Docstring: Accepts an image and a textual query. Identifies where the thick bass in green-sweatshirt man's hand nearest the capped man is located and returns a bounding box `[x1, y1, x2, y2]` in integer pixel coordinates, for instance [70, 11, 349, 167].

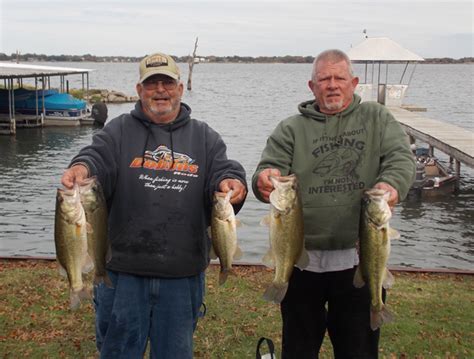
[262, 175, 309, 303]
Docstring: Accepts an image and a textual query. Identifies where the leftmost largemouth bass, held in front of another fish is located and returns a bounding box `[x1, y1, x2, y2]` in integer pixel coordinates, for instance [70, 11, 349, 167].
[54, 185, 91, 309]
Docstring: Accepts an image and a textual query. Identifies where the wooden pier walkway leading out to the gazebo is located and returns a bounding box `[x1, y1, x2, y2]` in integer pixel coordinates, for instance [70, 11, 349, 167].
[389, 106, 474, 178]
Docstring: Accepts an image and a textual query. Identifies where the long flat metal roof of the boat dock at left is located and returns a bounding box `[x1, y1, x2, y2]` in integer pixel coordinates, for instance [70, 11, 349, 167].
[0, 62, 94, 79]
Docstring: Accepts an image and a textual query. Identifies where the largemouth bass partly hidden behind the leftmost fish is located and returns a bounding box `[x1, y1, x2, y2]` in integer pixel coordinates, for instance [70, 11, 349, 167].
[79, 177, 112, 287]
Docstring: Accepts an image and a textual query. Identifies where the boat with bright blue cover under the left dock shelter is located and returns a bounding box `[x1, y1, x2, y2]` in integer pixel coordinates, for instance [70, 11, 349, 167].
[0, 88, 90, 127]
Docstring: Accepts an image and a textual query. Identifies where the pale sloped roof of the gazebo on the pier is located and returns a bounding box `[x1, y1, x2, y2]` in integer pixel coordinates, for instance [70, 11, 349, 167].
[347, 37, 424, 61]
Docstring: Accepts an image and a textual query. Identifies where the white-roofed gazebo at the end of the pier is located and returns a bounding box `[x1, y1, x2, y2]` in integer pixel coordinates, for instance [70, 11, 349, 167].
[347, 37, 424, 106]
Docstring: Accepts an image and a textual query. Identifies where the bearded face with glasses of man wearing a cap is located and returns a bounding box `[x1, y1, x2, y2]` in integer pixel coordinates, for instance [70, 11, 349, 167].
[137, 75, 183, 123]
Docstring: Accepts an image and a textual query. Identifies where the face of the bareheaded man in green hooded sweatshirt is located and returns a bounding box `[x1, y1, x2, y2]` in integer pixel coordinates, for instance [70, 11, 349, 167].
[308, 60, 359, 115]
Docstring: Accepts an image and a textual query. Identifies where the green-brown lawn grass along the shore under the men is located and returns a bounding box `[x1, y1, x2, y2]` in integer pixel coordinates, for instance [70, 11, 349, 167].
[0, 260, 474, 359]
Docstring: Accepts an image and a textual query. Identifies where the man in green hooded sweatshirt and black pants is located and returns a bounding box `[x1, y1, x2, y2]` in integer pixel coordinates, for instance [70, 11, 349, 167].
[252, 50, 415, 359]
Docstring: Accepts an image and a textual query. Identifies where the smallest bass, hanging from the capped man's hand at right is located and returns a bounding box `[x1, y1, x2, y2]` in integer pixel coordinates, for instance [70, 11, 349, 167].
[211, 191, 242, 285]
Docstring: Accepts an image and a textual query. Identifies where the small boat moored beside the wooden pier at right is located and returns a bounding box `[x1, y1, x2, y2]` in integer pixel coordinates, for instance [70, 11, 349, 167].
[409, 148, 458, 198]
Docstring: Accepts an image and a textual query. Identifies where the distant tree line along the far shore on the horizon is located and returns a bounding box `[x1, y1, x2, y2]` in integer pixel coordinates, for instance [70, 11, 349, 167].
[0, 53, 474, 64]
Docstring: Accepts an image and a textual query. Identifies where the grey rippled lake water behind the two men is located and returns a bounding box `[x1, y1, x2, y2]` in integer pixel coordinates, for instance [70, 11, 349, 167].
[0, 63, 474, 269]
